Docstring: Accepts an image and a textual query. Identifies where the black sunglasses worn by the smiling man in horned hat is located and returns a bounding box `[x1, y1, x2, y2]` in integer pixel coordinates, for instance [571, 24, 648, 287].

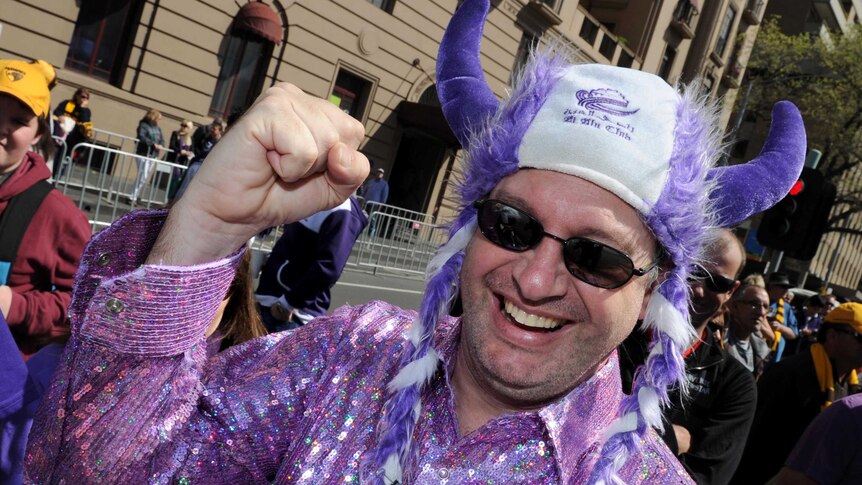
[473, 199, 659, 289]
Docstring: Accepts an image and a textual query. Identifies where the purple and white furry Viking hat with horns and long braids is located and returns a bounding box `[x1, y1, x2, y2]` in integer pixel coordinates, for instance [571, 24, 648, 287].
[367, 0, 806, 484]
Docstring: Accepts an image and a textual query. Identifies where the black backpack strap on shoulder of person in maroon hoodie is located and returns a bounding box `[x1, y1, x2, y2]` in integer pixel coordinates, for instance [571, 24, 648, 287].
[0, 180, 54, 284]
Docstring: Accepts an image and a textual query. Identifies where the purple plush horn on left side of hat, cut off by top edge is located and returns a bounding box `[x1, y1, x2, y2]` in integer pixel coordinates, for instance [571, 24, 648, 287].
[437, 0, 500, 147]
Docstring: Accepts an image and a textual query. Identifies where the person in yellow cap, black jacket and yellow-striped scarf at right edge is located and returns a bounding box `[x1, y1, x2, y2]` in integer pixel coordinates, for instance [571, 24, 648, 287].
[734, 303, 862, 484]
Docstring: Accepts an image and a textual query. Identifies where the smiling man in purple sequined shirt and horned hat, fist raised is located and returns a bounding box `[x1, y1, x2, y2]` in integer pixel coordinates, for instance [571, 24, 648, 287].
[26, 0, 805, 484]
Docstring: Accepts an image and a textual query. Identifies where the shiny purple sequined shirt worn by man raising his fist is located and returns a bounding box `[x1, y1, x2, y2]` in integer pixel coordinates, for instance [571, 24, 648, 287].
[25, 212, 691, 484]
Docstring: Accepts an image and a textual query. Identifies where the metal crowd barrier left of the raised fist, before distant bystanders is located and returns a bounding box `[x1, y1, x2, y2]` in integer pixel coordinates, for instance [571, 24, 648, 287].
[54, 143, 187, 232]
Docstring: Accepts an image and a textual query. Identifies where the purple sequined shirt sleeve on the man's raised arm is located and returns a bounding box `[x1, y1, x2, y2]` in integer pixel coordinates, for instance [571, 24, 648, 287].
[25, 212, 360, 483]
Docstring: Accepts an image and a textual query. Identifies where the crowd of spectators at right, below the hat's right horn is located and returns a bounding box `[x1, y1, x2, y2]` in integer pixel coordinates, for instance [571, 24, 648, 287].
[620, 225, 862, 484]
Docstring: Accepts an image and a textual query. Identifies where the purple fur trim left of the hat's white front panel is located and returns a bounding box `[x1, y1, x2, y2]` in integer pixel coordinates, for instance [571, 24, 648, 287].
[456, 49, 565, 208]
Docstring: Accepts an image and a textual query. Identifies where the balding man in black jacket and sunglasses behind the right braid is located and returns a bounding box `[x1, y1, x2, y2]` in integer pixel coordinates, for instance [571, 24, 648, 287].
[620, 229, 757, 485]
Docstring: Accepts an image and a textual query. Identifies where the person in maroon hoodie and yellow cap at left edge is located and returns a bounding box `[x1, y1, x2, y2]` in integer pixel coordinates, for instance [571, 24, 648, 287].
[0, 59, 90, 356]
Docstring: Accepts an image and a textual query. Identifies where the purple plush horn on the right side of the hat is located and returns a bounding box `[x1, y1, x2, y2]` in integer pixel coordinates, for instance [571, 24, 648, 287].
[708, 101, 806, 227]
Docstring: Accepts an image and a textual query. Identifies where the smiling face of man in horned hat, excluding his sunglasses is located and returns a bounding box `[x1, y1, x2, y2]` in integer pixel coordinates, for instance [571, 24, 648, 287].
[462, 169, 656, 409]
